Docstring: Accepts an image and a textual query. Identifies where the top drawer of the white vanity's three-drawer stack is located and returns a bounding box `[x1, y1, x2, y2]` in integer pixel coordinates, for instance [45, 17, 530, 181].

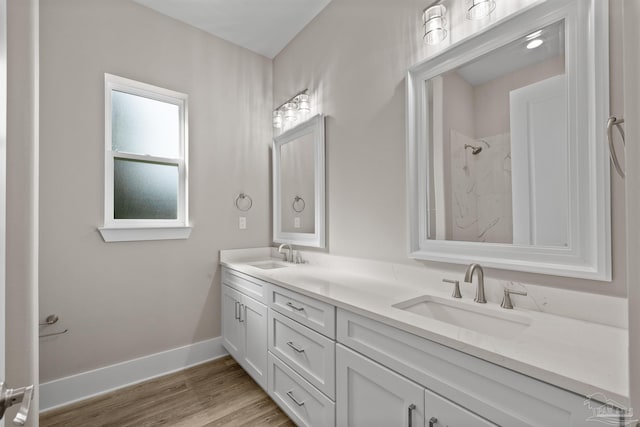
[269, 286, 336, 338]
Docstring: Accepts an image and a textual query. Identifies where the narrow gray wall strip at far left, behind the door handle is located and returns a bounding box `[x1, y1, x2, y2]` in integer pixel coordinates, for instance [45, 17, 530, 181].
[6, 0, 40, 427]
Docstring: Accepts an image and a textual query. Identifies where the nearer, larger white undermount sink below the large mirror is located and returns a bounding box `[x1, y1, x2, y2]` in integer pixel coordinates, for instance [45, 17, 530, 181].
[393, 295, 531, 338]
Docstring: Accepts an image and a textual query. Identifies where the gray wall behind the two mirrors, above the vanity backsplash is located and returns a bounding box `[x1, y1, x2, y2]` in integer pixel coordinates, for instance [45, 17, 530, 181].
[273, 0, 626, 296]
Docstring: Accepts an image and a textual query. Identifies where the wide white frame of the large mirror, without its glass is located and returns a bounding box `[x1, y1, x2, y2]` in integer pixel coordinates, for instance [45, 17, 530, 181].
[407, 0, 611, 281]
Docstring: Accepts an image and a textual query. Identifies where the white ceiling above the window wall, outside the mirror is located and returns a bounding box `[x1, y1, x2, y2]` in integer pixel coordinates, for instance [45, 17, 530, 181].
[134, 0, 331, 58]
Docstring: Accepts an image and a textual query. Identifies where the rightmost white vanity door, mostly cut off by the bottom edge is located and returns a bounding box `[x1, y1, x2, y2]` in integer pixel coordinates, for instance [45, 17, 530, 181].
[424, 390, 497, 427]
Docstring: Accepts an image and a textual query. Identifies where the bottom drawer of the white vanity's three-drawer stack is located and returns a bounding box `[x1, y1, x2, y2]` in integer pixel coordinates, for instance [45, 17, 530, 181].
[269, 353, 336, 427]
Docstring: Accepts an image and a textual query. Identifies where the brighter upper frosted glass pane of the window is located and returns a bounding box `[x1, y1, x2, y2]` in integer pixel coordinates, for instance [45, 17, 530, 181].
[111, 90, 180, 158]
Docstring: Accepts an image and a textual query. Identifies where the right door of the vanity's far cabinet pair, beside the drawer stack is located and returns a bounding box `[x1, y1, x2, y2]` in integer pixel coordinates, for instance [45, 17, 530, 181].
[240, 295, 268, 390]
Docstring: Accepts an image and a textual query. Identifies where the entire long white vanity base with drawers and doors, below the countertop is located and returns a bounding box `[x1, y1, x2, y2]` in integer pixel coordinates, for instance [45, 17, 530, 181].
[222, 268, 623, 427]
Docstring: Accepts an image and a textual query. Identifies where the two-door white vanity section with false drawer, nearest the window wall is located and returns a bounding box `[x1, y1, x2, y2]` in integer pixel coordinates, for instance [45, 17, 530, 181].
[222, 268, 268, 390]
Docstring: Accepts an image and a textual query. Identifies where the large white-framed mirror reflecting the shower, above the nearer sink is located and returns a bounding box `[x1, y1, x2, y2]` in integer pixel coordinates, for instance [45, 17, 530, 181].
[407, 0, 611, 281]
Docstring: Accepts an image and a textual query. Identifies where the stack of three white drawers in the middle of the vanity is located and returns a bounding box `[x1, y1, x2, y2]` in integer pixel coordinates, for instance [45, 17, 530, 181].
[268, 285, 336, 427]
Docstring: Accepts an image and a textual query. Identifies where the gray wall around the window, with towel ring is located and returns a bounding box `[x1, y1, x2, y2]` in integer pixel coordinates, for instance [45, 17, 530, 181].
[40, 0, 272, 382]
